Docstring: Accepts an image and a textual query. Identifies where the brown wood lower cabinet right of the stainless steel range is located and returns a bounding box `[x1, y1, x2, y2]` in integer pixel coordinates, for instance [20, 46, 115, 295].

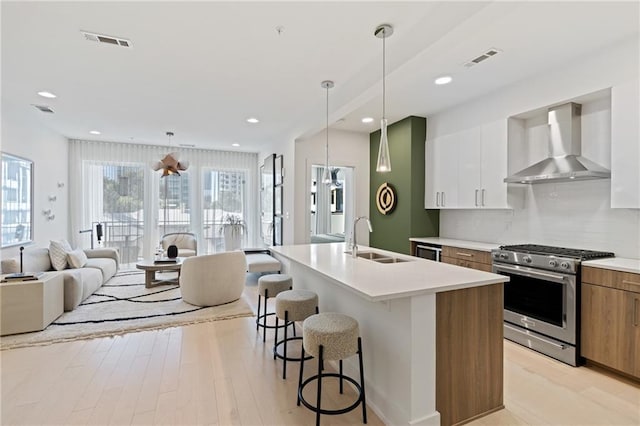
[580, 267, 640, 379]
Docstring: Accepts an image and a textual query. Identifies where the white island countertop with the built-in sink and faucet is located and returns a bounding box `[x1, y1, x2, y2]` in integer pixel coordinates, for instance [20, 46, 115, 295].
[270, 243, 509, 301]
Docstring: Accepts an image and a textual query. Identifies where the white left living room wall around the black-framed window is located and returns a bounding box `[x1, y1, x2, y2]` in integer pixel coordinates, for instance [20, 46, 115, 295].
[1, 106, 70, 258]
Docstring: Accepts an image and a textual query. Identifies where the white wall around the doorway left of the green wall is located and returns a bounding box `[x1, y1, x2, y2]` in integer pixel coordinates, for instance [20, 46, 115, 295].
[292, 129, 369, 245]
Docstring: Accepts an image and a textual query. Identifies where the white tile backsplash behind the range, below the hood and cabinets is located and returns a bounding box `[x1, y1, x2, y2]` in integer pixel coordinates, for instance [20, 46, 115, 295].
[440, 179, 640, 258]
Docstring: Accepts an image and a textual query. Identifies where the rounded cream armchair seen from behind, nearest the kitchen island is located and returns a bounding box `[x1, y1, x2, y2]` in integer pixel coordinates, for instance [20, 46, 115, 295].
[180, 251, 247, 306]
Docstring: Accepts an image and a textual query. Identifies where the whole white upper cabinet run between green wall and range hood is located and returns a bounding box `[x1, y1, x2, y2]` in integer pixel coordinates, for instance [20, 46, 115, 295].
[425, 119, 508, 209]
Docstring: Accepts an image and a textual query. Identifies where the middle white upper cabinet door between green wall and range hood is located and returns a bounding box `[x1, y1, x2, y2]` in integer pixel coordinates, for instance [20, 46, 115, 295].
[458, 127, 483, 209]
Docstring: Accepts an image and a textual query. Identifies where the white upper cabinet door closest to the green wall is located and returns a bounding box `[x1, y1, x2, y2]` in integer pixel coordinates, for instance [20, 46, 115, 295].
[424, 134, 458, 209]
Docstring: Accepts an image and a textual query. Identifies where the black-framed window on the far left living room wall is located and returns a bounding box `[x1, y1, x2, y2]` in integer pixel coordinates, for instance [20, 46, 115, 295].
[1, 153, 33, 247]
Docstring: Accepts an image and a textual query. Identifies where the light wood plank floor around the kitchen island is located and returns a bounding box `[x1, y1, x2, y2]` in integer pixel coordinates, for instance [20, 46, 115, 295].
[0, 278, 640, 426]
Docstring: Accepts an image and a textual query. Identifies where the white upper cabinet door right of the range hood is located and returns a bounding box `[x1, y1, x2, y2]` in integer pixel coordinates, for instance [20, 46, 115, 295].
[611, 80, 640, 209]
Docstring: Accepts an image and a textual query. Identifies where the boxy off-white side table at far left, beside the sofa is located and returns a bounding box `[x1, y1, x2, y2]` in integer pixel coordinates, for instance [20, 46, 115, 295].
[0, 272, 64, 336]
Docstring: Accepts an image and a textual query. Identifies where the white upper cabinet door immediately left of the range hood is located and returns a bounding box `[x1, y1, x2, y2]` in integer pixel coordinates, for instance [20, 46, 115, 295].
[478, 119, 508, 208]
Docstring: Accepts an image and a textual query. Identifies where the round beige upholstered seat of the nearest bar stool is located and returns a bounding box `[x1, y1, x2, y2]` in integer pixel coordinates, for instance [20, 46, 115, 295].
[302, 312, 360, 360]
